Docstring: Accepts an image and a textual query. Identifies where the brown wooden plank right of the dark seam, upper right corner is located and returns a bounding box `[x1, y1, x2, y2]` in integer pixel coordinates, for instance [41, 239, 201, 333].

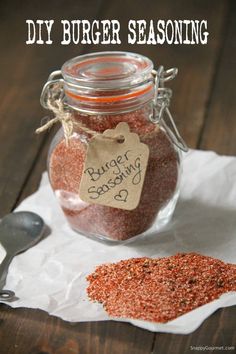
[199, 1, 236, 155]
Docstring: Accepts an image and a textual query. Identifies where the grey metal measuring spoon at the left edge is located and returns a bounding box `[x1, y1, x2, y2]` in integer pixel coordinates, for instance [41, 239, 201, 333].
[0, 211, 45, 301]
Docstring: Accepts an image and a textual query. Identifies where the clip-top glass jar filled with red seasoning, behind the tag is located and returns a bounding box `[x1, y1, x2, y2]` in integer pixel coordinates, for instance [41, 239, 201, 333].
[41, 52, 188, 242]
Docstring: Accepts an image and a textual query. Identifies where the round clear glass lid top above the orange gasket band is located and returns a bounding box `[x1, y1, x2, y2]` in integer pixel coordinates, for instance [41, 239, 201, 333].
[62, 52, 153, 91]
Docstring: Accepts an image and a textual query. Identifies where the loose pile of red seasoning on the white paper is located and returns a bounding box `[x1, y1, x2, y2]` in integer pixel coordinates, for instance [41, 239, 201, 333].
[87, 253, 236, 322]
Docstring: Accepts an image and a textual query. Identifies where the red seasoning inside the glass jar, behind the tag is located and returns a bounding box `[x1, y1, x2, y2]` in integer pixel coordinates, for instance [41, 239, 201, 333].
[49, 105, 179, 240]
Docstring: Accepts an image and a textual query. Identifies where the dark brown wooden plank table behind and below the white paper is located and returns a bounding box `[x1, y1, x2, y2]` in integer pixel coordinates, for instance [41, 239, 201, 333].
[0, 0, 236, 354]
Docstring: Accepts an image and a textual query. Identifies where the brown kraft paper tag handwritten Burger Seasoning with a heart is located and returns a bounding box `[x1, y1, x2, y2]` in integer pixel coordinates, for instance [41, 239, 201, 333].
[79, 122, 149, 210]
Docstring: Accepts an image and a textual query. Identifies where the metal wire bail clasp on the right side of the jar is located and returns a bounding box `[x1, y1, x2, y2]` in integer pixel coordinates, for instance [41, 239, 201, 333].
[149, 66, 188, 152]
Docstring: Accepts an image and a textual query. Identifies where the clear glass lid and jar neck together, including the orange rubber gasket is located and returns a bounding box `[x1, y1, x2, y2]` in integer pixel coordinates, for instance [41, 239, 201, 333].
[61, 52, 154, 114]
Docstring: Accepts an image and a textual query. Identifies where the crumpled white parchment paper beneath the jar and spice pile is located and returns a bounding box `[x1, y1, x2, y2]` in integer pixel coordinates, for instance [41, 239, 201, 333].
[0, 150, 236, 334]
